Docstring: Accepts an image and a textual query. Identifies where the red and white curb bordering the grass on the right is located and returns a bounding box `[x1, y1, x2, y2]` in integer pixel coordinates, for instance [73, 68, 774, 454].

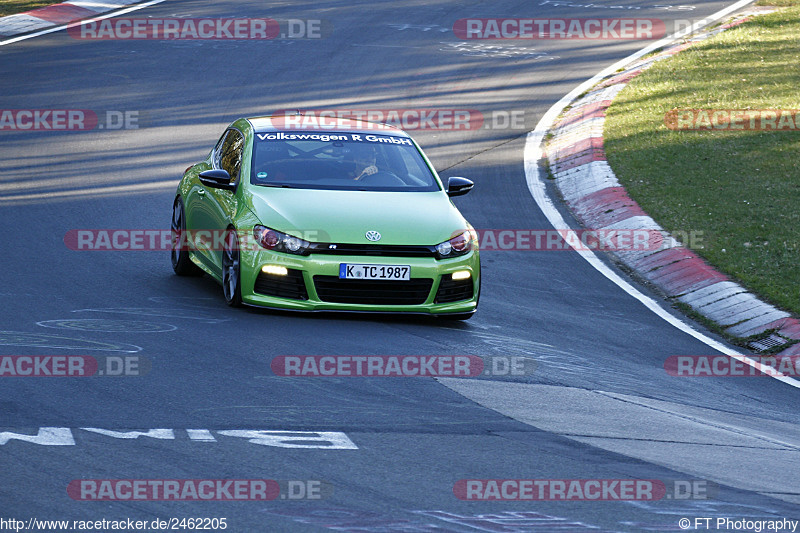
[546, 14, 800, 355]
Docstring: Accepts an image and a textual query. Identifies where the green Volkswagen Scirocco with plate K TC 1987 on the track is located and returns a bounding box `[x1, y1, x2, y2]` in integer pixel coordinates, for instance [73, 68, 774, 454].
[172, 116, 481, 320]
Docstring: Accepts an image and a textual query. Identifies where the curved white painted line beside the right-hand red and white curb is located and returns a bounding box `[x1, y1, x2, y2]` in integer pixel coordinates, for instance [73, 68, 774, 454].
[524, 0, 800, 389]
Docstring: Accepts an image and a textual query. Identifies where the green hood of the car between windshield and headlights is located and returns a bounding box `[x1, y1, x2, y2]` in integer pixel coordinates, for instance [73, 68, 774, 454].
[249, 187, 469, 245]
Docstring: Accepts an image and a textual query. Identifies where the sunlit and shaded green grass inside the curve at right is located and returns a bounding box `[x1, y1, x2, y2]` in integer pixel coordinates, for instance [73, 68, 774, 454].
[604, 6, 800, 314]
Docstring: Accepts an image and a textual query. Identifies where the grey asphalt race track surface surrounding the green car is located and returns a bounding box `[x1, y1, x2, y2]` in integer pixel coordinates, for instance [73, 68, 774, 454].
[0, 0, 800, 532]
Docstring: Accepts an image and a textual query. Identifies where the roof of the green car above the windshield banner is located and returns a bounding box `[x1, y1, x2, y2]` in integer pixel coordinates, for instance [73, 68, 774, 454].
[247, 112, 409, 137]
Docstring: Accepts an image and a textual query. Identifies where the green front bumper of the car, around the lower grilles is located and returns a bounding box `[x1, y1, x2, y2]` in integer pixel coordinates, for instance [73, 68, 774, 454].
[234, 250, 480, 314]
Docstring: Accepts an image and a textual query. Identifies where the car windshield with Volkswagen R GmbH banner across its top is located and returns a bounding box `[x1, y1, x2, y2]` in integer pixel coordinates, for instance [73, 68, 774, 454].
[250, 132, 440, 191]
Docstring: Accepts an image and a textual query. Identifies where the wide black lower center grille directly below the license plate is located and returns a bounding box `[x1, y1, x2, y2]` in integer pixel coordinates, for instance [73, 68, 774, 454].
[314, 276, 433, 305]
